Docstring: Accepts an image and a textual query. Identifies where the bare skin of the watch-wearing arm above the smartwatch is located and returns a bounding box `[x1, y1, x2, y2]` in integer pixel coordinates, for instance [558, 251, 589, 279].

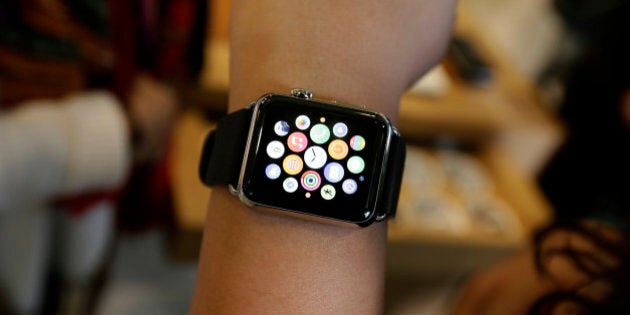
[230, 0, 455, 120]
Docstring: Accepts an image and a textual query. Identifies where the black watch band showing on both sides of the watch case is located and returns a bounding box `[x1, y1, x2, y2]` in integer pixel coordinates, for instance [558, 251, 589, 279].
[199, 108, 406, 221]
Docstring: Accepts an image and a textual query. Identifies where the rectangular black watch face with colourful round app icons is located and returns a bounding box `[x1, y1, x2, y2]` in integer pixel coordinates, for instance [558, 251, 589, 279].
[241, 95, 390, 223]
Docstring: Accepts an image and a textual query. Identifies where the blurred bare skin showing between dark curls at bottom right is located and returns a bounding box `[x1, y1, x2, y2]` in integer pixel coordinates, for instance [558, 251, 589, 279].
[451, 223, 621, 315]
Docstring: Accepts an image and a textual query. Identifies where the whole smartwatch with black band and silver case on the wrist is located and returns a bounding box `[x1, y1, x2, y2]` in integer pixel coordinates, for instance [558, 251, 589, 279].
[199, 89, 405, 226]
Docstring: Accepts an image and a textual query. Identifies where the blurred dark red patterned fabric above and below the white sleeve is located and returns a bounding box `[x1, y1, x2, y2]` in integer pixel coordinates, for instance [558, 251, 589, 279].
[0, 0, 206, 225]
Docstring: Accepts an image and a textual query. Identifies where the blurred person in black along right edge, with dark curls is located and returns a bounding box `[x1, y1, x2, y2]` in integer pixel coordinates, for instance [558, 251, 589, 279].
[453, 0, 630, 315]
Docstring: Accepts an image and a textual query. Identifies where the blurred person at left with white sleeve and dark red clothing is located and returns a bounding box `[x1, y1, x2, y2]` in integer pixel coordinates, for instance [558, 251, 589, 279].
[0, 0, 205, 314]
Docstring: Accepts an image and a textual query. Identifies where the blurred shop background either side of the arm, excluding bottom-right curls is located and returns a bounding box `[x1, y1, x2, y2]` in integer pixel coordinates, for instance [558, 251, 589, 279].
[0, 0, 630, 315]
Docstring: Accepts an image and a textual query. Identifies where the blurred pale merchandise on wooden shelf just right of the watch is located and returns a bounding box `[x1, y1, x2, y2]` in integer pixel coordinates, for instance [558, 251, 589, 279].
[400, 146, 523, 240]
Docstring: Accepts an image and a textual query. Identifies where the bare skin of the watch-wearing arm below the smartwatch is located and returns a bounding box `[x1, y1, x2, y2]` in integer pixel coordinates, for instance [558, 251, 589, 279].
[193, 187, 387, 314]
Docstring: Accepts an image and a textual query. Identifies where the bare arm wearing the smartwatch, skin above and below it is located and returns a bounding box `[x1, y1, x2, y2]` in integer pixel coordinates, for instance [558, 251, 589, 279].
[191, 1, 455, 314]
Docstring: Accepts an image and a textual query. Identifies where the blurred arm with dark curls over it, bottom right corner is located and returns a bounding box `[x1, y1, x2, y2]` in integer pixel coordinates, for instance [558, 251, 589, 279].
[451, 221, 627, 315]
